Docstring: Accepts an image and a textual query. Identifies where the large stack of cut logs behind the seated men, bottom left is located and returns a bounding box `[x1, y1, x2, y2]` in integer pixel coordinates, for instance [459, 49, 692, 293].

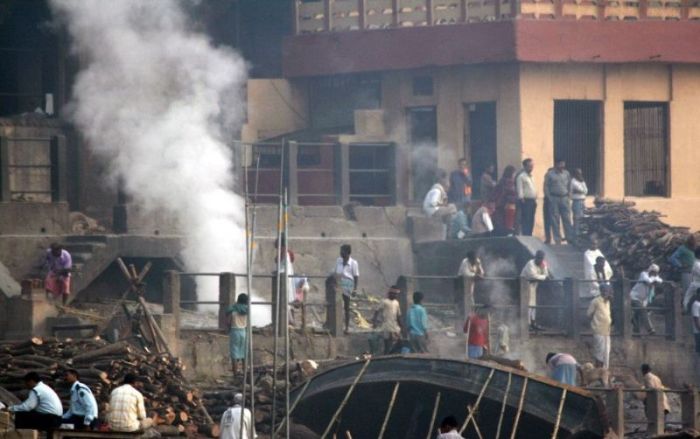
[0, 337, 218, 437]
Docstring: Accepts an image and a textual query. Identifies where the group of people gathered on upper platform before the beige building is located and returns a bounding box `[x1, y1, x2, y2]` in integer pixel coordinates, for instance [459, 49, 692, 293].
[423, 158, 588, 244]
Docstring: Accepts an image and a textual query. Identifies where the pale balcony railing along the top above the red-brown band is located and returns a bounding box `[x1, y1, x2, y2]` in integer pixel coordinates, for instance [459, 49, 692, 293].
[294, 0, 700, 35]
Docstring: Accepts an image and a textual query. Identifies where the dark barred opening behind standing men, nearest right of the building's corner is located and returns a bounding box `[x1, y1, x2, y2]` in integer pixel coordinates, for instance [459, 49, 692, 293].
[550, 101, 601, 194]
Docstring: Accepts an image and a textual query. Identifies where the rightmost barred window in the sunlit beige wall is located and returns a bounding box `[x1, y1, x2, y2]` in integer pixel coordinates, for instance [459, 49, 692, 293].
[624, 102, 669, 197]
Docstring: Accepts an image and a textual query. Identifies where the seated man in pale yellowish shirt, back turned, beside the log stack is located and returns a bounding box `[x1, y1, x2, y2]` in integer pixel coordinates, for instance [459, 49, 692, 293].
[107, 373, 153, 432]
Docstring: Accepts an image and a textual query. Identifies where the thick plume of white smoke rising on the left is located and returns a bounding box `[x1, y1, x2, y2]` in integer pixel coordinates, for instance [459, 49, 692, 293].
[51, 0, 268, 320]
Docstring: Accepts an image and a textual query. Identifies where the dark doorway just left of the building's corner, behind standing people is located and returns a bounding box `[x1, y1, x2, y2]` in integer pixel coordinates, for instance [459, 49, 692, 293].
[465, 102, 497, 197]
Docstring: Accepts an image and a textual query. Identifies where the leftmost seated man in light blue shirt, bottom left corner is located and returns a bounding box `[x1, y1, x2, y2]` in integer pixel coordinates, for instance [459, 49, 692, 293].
[9, 372, 63, 431]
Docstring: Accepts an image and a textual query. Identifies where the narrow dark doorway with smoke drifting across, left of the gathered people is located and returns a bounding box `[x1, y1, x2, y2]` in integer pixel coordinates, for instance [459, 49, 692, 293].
[408, 107, 437, 202]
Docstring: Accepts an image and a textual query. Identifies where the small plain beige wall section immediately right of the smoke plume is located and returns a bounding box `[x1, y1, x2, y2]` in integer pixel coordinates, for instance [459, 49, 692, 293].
[241, 79, 309, 142]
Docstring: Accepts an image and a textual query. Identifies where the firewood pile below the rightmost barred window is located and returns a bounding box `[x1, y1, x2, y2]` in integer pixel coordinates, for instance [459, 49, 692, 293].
[582, 199, 690, 278]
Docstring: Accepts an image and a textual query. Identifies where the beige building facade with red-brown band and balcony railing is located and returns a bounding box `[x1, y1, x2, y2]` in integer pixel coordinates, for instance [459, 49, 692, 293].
[244, 0, 700, 228]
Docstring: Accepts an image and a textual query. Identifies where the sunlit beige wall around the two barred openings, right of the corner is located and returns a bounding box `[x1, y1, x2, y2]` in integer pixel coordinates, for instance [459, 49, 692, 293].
[516, 64, 700, 233]
